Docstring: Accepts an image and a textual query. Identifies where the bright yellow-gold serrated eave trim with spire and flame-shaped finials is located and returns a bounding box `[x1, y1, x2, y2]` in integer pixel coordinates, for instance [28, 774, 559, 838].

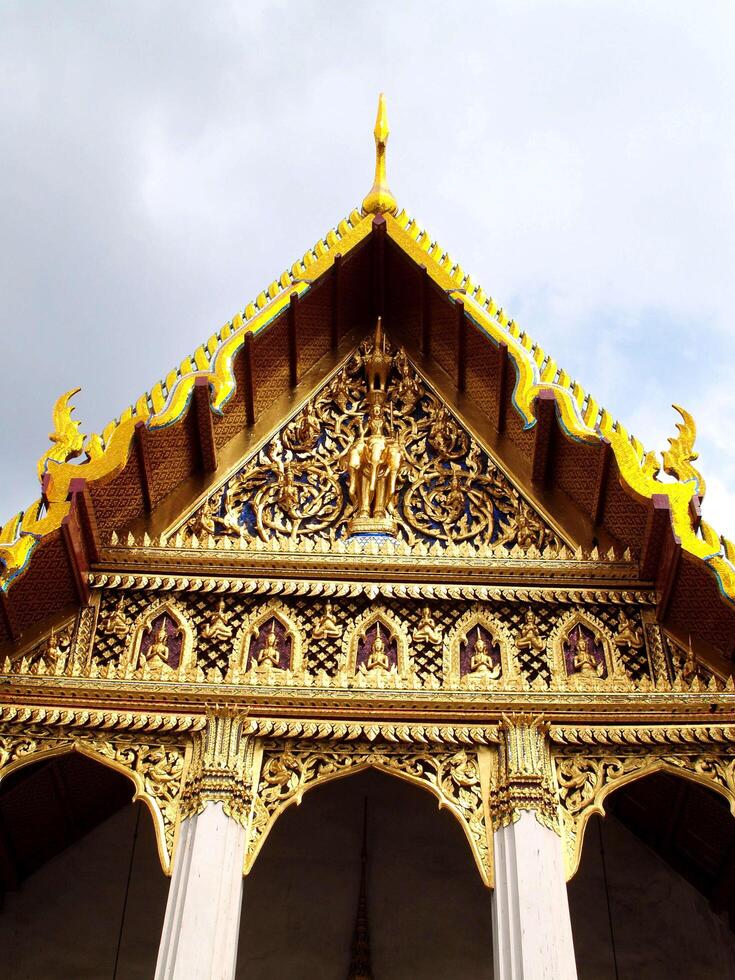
[0, 96, 735, 602]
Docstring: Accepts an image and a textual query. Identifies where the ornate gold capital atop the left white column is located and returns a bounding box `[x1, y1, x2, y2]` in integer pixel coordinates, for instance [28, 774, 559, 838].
[181, 708, 255, 827]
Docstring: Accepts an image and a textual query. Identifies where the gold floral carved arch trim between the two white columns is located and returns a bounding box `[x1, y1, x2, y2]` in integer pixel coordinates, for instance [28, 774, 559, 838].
[245, 741, 492, 885]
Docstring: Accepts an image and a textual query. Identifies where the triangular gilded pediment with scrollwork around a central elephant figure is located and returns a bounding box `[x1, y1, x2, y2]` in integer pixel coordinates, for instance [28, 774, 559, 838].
[164, 334, 565, 557]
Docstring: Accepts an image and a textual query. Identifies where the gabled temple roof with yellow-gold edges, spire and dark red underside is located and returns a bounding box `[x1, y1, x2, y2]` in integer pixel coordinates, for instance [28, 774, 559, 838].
[0, 96, 735, 657]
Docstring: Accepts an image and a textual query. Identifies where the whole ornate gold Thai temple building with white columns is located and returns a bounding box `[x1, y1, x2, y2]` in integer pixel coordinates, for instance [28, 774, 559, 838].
[0, 96, 735, 980]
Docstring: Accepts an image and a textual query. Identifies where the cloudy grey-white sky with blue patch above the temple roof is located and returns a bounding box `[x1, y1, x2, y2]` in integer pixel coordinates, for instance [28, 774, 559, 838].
[0, 0, 735, 536]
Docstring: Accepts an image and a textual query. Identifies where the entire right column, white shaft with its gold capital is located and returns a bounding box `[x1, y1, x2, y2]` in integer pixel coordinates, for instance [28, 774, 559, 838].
[490, 716, 577, 980]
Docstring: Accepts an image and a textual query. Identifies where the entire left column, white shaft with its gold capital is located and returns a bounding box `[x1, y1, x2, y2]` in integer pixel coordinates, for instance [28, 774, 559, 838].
[155, 713, 257, 980]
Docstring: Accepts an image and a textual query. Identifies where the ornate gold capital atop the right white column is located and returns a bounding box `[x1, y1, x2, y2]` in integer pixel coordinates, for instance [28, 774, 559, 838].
[490, 714, 559, 834]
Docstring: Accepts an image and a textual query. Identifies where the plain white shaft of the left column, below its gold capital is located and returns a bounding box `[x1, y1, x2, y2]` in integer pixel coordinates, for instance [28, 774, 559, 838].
[155, 802, 247, 980]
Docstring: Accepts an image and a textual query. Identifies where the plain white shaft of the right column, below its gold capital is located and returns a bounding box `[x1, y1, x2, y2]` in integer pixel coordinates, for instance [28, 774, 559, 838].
[492, 810, 577, 980]
